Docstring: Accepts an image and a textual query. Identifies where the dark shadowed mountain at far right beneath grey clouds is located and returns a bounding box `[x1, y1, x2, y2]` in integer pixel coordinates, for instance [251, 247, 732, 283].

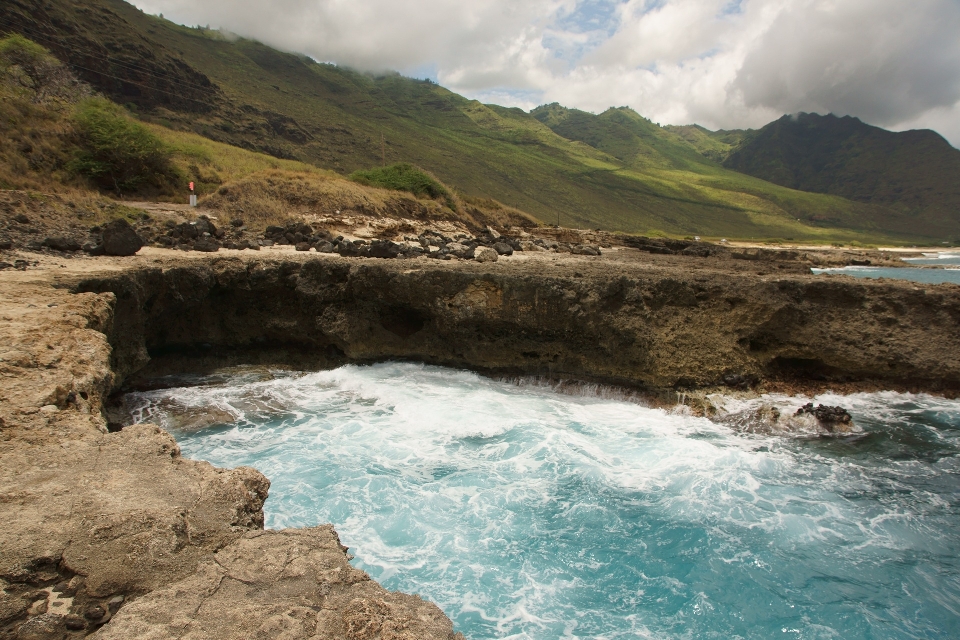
[723, 113, 960, 233]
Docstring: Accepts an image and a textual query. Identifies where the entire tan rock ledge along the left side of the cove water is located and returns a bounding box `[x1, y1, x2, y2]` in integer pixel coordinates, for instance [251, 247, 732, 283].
[0, 272, 456, 640]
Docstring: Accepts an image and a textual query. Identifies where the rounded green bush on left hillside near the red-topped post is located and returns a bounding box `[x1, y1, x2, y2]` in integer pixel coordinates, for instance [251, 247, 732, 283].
[70, 98, 180, 194]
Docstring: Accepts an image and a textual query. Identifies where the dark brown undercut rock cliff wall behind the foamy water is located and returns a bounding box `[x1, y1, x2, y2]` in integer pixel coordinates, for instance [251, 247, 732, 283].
[75, 253, 960, 391]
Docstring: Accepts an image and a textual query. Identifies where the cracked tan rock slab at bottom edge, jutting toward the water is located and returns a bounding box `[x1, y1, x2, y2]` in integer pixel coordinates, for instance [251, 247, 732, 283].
[93, 525, 453, 640]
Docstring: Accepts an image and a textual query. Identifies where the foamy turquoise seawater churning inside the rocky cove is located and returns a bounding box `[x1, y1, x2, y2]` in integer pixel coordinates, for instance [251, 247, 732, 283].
[127, 363, 960, 640]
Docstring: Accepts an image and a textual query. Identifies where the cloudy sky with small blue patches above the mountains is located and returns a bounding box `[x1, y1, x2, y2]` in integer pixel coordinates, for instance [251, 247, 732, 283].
[134, 0, 960, 147]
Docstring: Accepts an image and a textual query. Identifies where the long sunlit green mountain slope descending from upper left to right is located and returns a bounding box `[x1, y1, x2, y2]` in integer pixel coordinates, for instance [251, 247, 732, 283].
[0, 0, 948, 241]
